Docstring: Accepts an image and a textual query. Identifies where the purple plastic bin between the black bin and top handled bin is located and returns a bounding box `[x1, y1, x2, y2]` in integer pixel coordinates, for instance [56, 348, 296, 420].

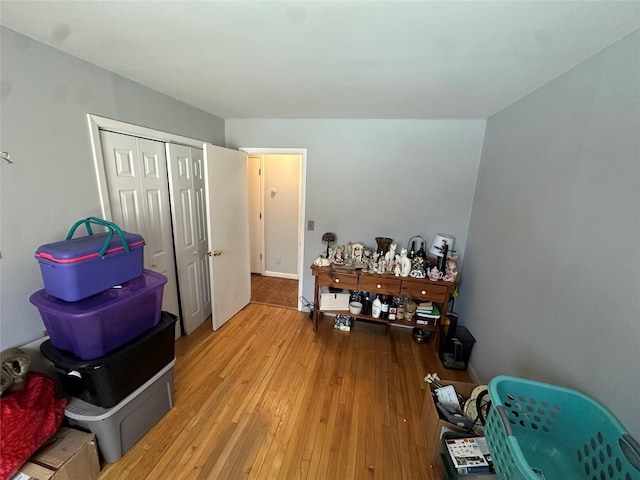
[29, 270, 167, 360]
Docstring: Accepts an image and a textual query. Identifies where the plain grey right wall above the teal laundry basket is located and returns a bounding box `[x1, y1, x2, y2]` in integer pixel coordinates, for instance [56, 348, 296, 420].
[459, 32, 640, 439]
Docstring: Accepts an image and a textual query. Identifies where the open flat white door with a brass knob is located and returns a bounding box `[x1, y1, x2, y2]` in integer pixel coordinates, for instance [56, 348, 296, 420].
[204, 144, 251, 330]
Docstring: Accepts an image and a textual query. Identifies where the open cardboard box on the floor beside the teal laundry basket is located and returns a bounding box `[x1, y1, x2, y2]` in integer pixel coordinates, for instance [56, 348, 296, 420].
[422, 380, 478, 466]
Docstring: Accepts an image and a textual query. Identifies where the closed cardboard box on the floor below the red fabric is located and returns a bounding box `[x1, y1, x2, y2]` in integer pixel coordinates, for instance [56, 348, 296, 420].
[11, 427, 100, 480]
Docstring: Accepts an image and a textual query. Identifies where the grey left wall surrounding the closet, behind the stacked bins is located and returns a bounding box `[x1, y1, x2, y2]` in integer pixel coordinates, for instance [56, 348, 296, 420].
[0, 28, 224, 349]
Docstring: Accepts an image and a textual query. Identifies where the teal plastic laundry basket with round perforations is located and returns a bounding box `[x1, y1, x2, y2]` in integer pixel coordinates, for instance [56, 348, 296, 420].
[485, 376, 640, 480]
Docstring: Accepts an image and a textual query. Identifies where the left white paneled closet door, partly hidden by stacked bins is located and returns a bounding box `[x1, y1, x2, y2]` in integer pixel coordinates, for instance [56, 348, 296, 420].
[100, 131, 180, 336]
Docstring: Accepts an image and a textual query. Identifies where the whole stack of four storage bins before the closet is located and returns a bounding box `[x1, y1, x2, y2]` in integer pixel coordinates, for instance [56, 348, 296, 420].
[29, 217, 176, 462]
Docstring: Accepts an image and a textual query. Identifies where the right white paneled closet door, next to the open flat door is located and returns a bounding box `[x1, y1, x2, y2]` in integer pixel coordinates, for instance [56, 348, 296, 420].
[167, 144, 208, 335]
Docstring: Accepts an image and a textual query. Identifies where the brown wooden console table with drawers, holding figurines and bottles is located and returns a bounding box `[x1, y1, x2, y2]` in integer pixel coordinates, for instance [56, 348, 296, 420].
[311, 265, 456, 348]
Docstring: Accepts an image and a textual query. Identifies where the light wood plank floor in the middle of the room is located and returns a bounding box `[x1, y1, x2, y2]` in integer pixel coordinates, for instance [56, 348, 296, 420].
[99, 304, 469, 480]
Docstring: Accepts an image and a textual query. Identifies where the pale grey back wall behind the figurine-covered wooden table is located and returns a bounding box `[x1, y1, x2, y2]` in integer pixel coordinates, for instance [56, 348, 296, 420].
[225, 119, 485, 306]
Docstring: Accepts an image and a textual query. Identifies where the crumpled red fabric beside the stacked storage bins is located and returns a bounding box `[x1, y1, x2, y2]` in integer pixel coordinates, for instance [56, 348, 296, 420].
[0, 372, 67, 480]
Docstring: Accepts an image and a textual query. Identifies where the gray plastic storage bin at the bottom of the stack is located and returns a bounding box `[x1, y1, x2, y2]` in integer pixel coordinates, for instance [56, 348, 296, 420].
[65, 359, 175, 463]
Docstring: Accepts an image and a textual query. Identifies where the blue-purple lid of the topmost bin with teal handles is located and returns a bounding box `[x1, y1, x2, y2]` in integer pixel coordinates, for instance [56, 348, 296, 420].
[35, 232, 144, 263]
